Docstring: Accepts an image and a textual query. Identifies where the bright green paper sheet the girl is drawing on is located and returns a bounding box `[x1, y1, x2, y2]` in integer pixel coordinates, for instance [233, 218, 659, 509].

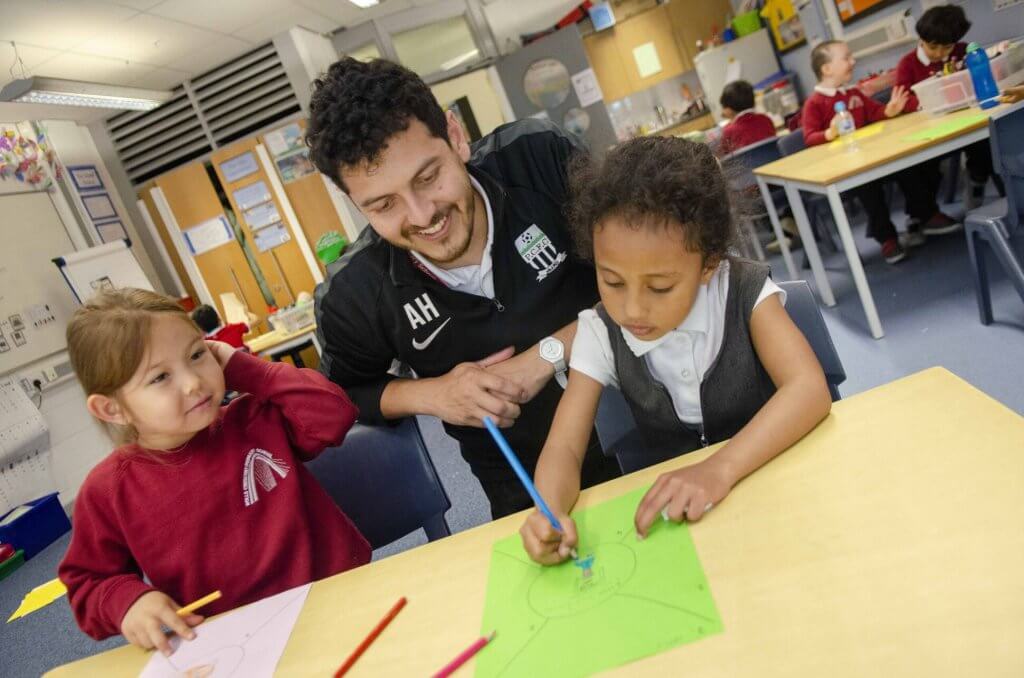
[476, 488, 722, 678]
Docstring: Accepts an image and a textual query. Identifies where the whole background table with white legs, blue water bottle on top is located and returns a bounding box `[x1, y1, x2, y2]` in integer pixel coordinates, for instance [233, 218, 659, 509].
[754, 108, 999, 339]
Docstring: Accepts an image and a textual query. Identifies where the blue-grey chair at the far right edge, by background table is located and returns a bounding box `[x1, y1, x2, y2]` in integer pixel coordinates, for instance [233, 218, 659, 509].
[964, 103, 1024, 325]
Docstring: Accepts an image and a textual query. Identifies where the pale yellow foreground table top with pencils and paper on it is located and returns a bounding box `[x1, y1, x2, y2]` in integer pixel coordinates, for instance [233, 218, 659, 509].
[41, 368, 1024, 678]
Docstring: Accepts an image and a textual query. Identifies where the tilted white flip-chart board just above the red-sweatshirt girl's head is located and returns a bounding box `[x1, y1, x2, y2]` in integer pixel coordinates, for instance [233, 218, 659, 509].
[53, 240, 153, 302]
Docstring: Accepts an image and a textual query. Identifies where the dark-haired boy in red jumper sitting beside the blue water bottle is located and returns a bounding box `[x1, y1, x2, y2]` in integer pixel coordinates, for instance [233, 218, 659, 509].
[896, 5, 1001, 210]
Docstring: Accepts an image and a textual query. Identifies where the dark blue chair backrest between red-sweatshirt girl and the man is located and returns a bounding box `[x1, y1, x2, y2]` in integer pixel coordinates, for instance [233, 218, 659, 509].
[306, 417, 452, 549]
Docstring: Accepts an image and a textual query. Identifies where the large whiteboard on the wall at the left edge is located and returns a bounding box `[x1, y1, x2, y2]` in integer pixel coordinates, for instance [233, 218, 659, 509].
[0, 190, 75, 375]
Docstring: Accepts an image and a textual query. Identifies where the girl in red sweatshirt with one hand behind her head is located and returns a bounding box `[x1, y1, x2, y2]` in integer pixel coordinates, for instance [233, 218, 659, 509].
[58, 289, 370, 653]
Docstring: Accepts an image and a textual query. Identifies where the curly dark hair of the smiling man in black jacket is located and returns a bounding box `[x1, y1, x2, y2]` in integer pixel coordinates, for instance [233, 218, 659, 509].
[306, 56, 449, 190]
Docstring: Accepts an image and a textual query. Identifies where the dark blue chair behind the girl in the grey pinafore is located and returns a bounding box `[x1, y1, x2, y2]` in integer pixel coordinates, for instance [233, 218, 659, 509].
[594, 281, 846, 473]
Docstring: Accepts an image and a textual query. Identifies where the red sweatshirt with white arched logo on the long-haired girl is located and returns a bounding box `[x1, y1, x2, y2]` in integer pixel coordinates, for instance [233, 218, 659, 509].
[57, 351, 370, 640]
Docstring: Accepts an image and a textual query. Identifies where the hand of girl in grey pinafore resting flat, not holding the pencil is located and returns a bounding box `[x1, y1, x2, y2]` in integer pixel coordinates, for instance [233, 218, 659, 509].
[634, 457, 736, 538]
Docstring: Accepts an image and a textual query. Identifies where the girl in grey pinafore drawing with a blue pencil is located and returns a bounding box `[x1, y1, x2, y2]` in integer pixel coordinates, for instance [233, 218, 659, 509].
[520, 137, 831, 564]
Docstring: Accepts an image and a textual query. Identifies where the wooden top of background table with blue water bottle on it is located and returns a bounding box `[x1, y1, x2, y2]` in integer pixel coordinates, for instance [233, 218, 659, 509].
[754, 104, 1007, 185]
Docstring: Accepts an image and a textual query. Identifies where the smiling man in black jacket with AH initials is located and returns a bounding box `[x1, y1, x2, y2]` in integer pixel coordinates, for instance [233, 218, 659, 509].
[307, 59, 618, 517]
